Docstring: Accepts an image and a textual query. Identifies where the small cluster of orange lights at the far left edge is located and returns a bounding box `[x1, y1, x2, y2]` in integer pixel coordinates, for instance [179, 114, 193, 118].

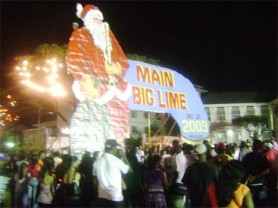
[0, 95, 19, 126]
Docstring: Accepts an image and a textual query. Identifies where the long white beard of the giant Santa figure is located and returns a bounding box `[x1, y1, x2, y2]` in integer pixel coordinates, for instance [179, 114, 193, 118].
[85, 22, 111, 57]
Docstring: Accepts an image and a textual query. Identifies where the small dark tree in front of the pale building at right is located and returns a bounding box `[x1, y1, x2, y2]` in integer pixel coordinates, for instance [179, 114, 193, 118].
[232, 115, 270, 139]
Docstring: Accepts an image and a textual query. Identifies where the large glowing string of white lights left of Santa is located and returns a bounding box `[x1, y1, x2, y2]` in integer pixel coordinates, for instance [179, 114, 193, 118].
[15, 58, 66, 96]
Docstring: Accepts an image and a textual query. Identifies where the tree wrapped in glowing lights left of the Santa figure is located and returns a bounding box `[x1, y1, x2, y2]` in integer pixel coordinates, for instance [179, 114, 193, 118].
[10, 43, 72, 91]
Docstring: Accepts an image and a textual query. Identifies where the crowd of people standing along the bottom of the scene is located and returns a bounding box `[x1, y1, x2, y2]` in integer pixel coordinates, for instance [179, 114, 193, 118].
[2, 136, 278, 208]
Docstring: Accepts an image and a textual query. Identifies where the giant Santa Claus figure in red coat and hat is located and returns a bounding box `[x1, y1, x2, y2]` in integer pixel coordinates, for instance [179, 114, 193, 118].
[66, 4, 131, 154]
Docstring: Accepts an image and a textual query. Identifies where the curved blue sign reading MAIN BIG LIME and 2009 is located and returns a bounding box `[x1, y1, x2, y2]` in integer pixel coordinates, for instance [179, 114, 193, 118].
[125, 60, 209, 140]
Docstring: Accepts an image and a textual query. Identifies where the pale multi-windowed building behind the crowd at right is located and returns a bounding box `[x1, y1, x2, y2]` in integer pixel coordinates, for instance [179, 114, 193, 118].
[202, 92, 277, 143]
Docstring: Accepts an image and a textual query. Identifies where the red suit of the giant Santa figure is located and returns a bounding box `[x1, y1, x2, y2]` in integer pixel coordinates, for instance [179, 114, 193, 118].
[66, 27, 129, 144]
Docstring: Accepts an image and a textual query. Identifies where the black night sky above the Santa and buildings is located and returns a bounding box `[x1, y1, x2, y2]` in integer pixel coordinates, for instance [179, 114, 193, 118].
[1, 0, 277, 93]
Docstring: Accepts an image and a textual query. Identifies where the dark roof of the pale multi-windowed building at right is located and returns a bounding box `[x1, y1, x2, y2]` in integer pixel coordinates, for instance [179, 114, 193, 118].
[202, 92, 277, 104]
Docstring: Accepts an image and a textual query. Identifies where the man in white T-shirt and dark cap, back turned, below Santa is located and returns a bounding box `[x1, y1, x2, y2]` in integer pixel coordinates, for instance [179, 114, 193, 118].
[93, 139, 131, 207]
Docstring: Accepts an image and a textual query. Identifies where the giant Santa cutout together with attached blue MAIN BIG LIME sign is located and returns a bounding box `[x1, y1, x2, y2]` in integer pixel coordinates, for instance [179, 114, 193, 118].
[66, 4, 209, 155]
